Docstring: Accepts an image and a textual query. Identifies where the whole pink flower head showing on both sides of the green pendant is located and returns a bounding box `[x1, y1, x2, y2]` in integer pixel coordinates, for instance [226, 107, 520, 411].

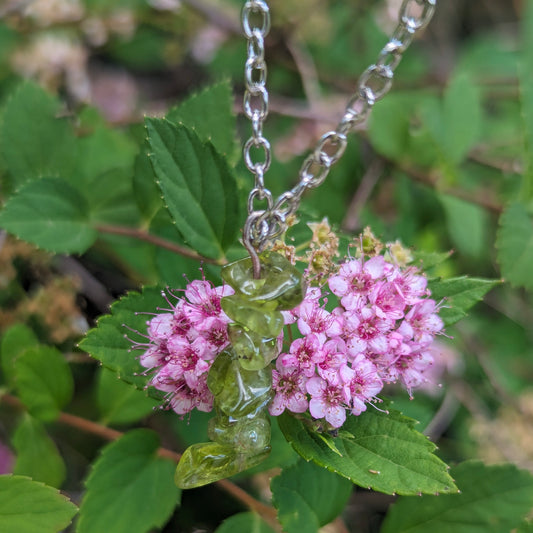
[138, 251, 443, 428]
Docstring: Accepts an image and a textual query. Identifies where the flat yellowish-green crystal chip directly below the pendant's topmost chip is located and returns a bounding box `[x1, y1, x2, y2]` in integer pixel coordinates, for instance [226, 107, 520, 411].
[220, 294, 283, 337]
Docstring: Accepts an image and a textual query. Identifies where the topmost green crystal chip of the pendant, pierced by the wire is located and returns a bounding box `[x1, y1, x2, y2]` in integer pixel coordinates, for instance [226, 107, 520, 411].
[222, 252, 304, 310]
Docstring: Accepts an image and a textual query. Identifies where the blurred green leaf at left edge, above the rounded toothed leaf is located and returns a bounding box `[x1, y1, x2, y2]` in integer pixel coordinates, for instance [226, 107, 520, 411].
[0, 82, 77, 186]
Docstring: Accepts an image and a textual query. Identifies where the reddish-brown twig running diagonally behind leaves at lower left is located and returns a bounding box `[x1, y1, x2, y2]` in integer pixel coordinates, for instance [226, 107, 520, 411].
[1, 394, 280, 531]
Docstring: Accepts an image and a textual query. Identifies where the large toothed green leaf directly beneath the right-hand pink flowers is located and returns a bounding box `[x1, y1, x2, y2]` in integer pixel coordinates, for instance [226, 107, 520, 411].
[279, 409, 457, 495]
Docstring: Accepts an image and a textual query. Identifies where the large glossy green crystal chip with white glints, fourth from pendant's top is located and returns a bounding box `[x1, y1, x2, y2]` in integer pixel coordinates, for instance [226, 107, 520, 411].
[207, 350, 272, 418]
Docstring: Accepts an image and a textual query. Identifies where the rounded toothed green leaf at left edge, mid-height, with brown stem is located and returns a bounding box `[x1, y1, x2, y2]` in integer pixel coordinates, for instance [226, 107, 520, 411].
[0, 178, 97, 253]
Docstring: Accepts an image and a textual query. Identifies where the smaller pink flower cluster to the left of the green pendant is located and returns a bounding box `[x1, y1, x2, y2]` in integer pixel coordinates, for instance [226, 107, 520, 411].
[135, 280, 234, 415]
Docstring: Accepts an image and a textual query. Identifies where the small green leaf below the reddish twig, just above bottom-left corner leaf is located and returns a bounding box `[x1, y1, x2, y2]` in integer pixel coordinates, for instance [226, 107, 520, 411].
[12, 414, 67, 488]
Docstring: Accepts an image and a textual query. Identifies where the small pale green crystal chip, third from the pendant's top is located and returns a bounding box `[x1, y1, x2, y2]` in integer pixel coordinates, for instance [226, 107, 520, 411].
[228, 324, 278, 370]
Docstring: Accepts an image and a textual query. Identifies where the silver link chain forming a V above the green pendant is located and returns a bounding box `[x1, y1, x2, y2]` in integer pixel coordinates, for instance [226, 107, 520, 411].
[242, 0, 437, 260]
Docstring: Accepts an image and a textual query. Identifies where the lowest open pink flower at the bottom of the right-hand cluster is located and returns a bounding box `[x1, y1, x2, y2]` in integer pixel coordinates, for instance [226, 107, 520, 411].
[306, 377, 348, 428]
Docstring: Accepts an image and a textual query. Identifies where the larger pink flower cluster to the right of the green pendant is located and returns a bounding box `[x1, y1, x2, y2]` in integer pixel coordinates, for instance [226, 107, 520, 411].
[269, 256, 443, 428]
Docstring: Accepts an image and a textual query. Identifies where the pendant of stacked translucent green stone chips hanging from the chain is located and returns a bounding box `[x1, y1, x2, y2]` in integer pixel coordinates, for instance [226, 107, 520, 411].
[175, 252, 305, 489]
